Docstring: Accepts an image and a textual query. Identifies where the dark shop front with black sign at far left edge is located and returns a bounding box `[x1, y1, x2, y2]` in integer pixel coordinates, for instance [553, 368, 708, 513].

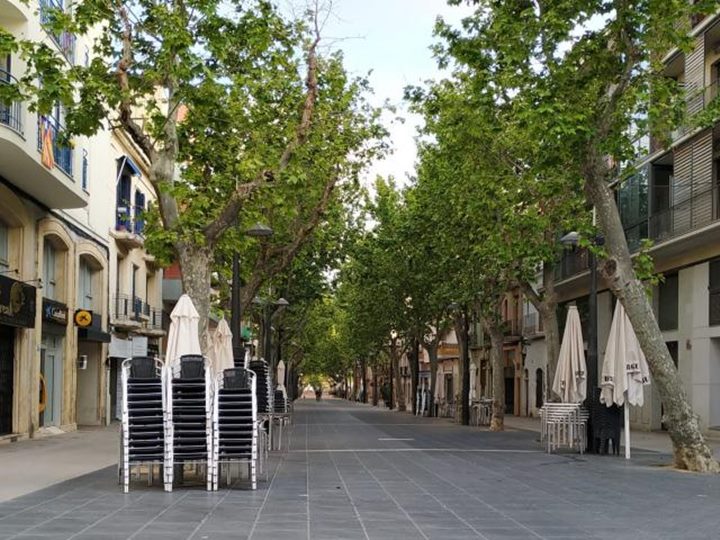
[0, 274, 36, 436]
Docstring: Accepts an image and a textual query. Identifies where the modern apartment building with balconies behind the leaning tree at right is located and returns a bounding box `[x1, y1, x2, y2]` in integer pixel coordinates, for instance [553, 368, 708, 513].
[524, 15, 720, 430]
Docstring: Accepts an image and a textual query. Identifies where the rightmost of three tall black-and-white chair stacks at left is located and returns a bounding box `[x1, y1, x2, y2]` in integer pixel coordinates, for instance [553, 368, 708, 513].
[212, 368, 258, 490]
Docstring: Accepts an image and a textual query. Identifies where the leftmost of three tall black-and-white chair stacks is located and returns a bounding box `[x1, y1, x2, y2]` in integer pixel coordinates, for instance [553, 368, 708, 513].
[121, 356, 172, 493]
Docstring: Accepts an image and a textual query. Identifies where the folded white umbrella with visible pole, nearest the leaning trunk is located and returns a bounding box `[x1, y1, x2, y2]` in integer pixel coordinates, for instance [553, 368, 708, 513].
[600, 302, 650, 459]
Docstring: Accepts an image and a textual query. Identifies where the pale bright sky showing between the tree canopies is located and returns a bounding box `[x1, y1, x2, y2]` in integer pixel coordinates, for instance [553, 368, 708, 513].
[287, 0, 478, 189]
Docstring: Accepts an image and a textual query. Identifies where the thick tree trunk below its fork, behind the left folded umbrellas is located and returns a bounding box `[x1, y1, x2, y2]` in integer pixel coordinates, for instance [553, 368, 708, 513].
[177, 243, 212, 354]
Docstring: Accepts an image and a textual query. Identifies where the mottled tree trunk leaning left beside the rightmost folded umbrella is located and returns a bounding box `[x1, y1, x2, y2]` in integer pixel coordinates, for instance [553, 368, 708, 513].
[585, 162, 720, 472]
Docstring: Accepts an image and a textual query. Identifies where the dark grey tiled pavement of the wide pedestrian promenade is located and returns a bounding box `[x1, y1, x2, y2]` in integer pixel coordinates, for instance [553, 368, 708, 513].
[0, 400, 720, 540]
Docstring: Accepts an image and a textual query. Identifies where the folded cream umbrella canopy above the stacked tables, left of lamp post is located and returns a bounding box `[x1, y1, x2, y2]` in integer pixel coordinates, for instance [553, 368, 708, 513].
[553, 305, 587, 403]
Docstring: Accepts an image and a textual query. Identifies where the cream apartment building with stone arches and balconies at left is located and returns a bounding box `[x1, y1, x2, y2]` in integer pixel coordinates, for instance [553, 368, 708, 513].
[0, 0, 160, 440]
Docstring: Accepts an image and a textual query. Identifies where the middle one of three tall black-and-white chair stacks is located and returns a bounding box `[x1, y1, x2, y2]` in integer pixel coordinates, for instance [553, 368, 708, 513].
[167, 355, 213, 490]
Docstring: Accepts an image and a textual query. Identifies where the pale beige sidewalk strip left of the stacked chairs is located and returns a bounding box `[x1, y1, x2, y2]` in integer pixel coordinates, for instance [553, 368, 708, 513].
[0, 424, 119, 502]
